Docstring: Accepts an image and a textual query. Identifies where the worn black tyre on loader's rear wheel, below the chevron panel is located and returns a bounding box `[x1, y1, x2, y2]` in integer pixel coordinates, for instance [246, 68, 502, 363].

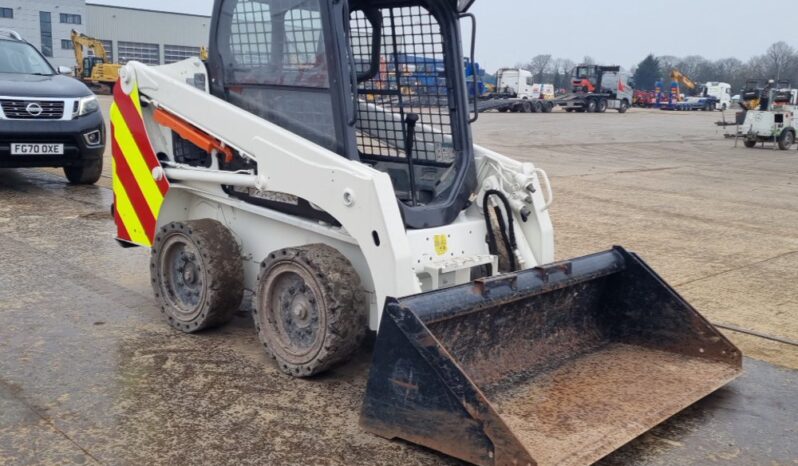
[150, 219, 244, 333]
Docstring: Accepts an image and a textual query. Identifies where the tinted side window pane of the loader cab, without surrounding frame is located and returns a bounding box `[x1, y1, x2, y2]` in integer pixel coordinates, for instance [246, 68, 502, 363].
[217, 0, 344, 154]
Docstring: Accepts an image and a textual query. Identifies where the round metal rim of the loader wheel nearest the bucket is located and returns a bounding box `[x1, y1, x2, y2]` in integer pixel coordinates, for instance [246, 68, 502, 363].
[258, 262, 326, 365]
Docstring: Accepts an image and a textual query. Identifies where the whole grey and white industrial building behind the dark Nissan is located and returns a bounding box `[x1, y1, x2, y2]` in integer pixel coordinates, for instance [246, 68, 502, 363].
[0, 0, 211, 66]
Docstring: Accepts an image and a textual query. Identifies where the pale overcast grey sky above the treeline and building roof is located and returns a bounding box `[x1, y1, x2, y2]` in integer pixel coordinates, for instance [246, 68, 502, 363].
[89, 0, 798, 71]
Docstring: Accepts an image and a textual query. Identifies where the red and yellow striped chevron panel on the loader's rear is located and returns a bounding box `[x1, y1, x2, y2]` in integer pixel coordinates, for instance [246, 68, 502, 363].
[111, 83, 169, 247]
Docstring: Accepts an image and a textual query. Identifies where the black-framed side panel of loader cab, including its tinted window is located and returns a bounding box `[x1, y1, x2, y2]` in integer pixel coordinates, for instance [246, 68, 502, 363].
[209, 0, 354, 157]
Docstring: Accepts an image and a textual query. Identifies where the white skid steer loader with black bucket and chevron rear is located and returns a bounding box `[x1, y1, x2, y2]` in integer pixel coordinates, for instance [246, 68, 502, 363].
[111, 0, 741, 465]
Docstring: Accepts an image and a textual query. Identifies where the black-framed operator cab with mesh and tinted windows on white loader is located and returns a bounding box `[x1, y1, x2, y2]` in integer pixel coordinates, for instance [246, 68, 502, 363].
[209, 0, 476, 228]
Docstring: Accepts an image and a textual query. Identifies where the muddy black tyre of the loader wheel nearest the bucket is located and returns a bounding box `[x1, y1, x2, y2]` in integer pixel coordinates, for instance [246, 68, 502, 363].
[253, 244, 368, 377]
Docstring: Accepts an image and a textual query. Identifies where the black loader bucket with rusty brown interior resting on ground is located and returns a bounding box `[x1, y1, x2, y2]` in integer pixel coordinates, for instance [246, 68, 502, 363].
[361, 247, 742, 465]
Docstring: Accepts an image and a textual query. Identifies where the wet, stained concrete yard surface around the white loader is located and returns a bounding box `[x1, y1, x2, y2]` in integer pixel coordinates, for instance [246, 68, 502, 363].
[0, 104, 798, 465]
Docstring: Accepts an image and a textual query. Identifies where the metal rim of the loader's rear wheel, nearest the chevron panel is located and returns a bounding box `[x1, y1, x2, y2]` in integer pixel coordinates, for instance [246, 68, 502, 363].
[159, 234, 206, 322]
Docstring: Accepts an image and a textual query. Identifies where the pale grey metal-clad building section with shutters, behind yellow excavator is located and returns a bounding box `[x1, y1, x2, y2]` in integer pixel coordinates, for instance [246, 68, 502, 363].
[86, 4, 211, 64]
